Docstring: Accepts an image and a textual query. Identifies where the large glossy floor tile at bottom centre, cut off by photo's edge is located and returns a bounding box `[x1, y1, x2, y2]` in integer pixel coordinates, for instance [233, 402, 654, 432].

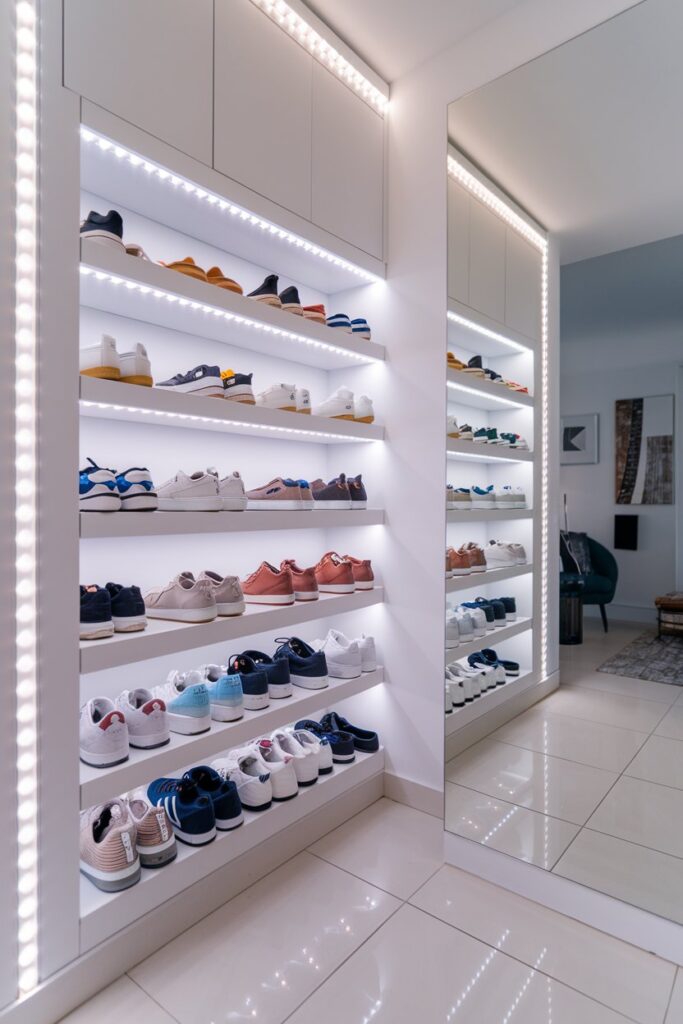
[290, 906, 627, 1024]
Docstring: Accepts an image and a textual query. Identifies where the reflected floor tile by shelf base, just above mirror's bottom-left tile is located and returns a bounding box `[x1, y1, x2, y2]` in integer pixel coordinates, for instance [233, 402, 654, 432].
[445, 739, 618, 825]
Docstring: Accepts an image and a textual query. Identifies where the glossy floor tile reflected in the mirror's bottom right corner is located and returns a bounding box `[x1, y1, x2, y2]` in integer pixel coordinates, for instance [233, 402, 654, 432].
[554, 828, 683, 925]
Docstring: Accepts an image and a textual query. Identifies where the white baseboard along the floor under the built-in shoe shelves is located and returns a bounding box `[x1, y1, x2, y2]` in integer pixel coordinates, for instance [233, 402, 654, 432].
[0, 772, 384, 1024]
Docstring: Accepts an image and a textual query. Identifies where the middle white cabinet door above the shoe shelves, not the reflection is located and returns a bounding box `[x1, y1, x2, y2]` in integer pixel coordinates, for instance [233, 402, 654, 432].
[214, 0, 313, 219]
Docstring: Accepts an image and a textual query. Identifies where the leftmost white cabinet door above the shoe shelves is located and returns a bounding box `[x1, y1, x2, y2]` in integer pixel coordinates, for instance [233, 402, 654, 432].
[63, 0, 213, 165]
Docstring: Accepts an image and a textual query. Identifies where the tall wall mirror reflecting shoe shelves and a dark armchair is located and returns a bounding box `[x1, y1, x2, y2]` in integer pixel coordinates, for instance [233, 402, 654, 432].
[445, 0, 683, 937]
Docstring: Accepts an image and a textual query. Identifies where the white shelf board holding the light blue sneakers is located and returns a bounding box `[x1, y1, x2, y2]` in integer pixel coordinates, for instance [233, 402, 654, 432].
[80, 668, 384, 809]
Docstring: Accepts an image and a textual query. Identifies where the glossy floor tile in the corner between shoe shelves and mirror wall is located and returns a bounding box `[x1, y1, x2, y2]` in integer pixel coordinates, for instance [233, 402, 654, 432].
[309, 800, 443, 899]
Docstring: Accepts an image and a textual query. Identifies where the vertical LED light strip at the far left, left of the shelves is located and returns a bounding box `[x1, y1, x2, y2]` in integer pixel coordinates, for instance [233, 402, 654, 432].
[14, 0, 38, 995]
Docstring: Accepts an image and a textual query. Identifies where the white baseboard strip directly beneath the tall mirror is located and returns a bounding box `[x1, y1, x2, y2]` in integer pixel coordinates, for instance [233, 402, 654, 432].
[443, 831, 683, 966]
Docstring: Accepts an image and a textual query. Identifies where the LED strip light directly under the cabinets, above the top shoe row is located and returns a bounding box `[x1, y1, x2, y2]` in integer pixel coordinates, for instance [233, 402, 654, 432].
[81, 131, 382, 284]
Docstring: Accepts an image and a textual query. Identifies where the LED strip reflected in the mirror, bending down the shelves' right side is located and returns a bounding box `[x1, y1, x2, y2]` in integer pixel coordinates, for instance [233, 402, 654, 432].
[446, 155, 550, 679]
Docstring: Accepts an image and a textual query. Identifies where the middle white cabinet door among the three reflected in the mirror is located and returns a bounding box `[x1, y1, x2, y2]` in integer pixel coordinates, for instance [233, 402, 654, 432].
[469, 199, 506, 324]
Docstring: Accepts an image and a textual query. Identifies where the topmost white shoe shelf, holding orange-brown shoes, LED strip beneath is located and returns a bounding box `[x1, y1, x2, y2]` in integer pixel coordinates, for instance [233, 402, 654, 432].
[81, 240, 385, 370]
